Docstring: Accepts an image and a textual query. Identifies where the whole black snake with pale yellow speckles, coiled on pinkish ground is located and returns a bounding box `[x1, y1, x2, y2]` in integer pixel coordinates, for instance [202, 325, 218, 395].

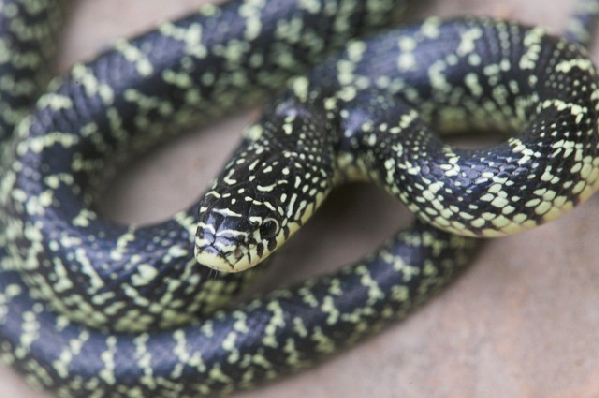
[0, 0, 599, 397]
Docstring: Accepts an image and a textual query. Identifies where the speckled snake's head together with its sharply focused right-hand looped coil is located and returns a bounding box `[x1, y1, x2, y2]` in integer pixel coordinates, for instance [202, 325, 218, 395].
[196, 18, 599, 272]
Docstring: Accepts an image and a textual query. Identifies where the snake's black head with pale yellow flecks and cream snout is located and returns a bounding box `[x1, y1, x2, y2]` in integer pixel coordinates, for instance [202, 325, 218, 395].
[195, 103, 333, 272]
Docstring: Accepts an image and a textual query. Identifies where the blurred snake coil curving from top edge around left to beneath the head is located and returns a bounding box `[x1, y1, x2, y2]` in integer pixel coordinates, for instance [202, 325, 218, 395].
[0, 1, 420, 331]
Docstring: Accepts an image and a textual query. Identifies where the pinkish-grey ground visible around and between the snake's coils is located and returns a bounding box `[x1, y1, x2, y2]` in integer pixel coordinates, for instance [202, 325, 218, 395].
[0, 0, 599, 398]
